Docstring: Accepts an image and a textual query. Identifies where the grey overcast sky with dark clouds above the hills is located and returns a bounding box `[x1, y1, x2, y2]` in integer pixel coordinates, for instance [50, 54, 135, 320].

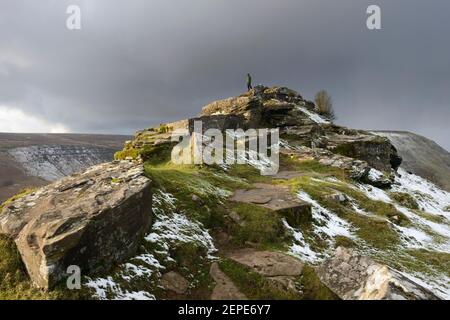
[0, 0, 450, 150]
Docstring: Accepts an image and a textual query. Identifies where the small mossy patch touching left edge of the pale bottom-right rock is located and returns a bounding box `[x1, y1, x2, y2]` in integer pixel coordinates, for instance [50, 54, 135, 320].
[299, 265, 339, 300]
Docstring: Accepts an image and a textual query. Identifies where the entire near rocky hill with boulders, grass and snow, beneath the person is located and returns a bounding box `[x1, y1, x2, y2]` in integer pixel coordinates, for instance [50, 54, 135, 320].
[0, 85, 450, 300]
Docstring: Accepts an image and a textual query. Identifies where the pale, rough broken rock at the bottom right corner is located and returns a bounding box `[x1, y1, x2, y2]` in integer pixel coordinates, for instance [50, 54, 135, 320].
[318, 247, 439, 300]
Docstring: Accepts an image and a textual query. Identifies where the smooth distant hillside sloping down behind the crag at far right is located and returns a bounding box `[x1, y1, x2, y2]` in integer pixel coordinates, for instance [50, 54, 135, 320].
[376, 131, 450, 191]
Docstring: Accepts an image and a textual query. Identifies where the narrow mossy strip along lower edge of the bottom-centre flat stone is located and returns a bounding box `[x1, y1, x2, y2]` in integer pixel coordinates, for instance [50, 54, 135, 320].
[219, 259, 301, 300]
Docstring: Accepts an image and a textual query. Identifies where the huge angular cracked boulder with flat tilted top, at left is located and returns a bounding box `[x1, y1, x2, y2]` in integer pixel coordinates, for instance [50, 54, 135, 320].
[0, 161, 152, 289]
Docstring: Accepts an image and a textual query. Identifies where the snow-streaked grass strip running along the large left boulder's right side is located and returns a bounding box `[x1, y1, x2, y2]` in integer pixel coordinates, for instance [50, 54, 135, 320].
[84, 190, 217, 300]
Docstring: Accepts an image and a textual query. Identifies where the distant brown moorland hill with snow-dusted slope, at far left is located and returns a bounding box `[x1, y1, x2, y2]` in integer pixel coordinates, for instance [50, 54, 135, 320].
[0, 133, 130, 202]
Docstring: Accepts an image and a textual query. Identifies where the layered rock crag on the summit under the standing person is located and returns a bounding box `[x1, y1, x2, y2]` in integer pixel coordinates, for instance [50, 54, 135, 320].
[119, 85, 401, 175]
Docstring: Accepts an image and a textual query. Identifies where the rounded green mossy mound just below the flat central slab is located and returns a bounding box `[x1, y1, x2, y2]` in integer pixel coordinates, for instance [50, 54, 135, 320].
[228, 203, 285, 247]
